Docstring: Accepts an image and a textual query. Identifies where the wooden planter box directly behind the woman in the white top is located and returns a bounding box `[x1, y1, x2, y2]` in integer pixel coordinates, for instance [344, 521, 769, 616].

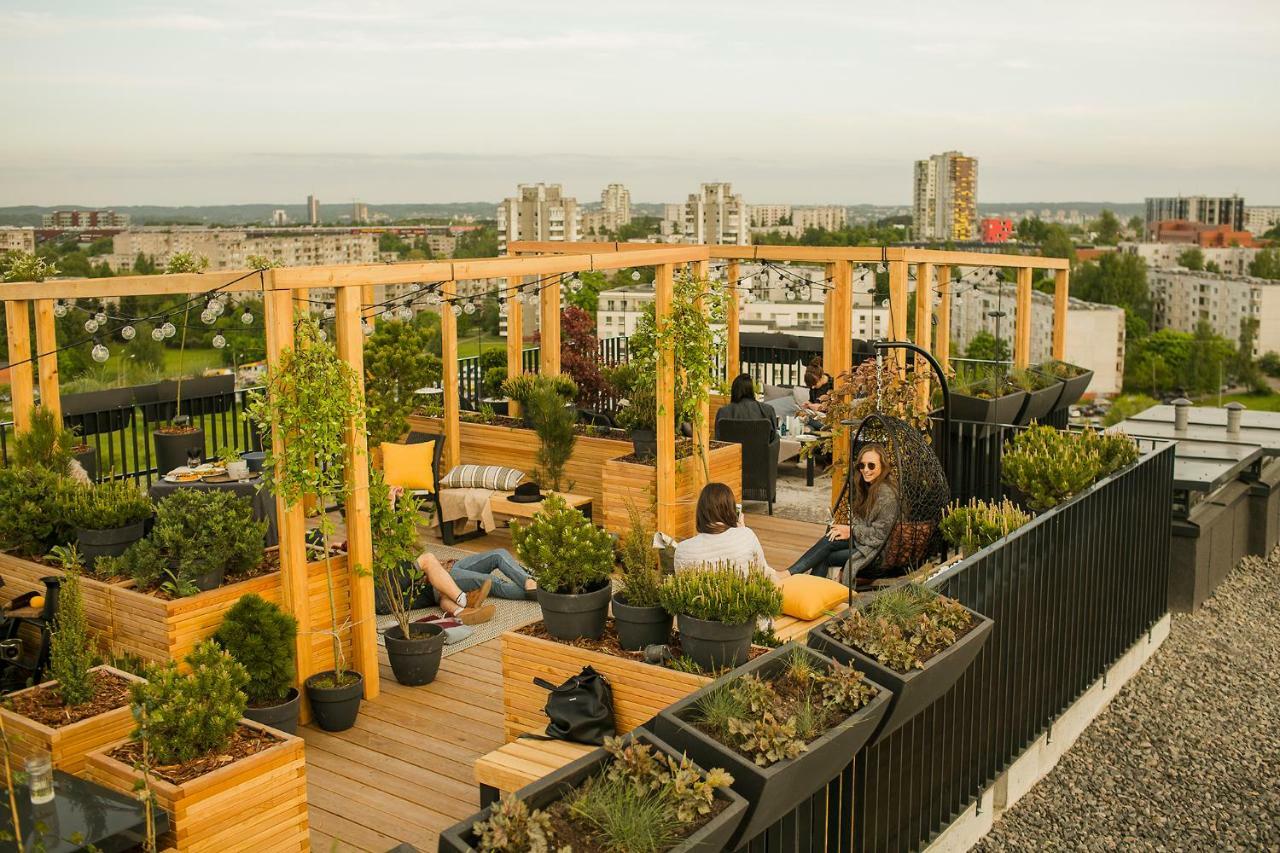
[603, 444, 742, 539]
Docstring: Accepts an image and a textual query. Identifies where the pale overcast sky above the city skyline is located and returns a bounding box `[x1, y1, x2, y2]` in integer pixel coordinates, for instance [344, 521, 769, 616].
[0, 0, 1280, 205]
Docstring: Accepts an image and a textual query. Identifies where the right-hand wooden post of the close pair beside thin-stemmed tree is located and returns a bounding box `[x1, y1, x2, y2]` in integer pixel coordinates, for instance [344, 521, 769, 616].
[334, 286, 379, 699]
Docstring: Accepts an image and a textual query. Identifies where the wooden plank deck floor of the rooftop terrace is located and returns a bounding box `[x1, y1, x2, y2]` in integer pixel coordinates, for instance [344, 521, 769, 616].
[309, 515, 822, 852]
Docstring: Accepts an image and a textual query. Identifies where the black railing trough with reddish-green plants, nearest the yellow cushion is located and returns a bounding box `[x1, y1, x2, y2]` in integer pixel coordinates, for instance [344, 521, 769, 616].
[809, 584, 992, 740]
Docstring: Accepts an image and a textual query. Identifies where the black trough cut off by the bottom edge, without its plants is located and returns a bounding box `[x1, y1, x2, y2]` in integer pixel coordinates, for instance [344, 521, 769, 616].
[438, 729, 746, 853]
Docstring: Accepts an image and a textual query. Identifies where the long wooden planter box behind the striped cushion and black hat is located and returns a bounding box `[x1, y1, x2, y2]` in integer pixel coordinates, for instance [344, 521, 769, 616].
[408, 415, 632, 524]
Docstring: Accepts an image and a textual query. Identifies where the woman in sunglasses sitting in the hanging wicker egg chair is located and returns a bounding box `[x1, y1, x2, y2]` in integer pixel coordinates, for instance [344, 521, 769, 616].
[790, 444, 897, 584]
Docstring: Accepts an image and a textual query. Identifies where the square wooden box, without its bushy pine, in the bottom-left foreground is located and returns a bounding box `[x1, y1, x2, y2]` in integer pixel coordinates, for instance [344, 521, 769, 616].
[84, 720, 311, 853]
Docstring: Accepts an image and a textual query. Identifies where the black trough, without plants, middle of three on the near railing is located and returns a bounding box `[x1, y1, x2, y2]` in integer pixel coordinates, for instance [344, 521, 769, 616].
[657, 643, 891, 849]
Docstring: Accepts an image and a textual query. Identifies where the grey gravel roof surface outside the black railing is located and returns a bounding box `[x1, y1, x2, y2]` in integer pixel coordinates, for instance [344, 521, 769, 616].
[975, 548, 1280, 850]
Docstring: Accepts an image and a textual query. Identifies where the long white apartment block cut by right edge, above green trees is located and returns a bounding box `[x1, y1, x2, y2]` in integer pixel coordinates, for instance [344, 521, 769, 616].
[1147, 269, 1280, 357]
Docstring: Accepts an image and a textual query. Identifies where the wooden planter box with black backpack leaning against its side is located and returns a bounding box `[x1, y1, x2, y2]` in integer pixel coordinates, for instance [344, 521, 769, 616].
[502, 631, 712, 742]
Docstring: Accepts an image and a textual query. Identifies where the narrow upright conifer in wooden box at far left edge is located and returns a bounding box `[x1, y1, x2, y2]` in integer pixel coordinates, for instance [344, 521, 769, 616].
[0, 555, 140, 775]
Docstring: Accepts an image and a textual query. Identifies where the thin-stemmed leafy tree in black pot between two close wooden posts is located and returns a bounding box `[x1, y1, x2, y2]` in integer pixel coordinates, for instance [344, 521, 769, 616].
[250, 319, 365, 731]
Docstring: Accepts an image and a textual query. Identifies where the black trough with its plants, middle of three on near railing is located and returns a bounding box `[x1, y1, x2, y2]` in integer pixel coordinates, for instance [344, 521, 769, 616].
[657, 643, 890, 849]
